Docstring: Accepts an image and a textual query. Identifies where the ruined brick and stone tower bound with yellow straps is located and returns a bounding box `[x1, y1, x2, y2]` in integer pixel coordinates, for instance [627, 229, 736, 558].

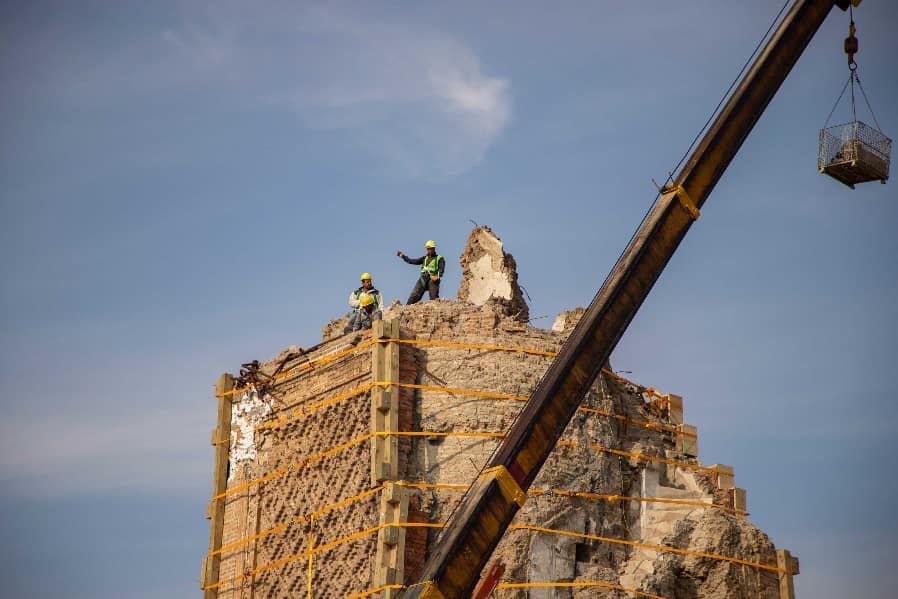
[202, 227, 797, 599]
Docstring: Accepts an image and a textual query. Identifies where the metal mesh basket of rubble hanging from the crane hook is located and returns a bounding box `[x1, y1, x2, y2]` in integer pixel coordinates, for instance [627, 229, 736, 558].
[817, 121, 892, 189]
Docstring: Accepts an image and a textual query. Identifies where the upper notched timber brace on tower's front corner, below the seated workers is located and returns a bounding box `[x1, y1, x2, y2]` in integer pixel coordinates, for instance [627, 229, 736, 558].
[371, 320, 399, 486]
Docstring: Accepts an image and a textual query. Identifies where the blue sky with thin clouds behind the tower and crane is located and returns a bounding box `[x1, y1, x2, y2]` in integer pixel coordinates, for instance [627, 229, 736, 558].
[0, 0, 898, 599]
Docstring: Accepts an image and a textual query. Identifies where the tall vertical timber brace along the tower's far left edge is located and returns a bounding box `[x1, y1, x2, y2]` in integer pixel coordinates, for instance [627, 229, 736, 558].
[200, 373, 234, 599]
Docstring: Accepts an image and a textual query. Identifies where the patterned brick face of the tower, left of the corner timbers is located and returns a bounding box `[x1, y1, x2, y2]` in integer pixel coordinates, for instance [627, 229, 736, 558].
[219, 338, 378, 599]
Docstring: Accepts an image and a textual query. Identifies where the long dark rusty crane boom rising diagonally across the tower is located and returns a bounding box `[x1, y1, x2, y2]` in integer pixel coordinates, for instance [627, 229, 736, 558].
[405, 0, 859, 599]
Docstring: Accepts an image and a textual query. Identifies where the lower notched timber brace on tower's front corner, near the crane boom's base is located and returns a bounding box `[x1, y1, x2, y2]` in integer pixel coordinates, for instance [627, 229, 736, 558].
[374, 483, 408, 599]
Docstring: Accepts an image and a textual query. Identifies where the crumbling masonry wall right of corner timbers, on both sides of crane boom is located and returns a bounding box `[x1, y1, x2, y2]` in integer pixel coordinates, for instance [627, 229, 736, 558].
[384, 300, 780, 598]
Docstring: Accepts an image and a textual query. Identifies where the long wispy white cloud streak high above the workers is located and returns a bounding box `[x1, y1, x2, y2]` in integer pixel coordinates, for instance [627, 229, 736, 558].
[35, 1, 512, 179]
